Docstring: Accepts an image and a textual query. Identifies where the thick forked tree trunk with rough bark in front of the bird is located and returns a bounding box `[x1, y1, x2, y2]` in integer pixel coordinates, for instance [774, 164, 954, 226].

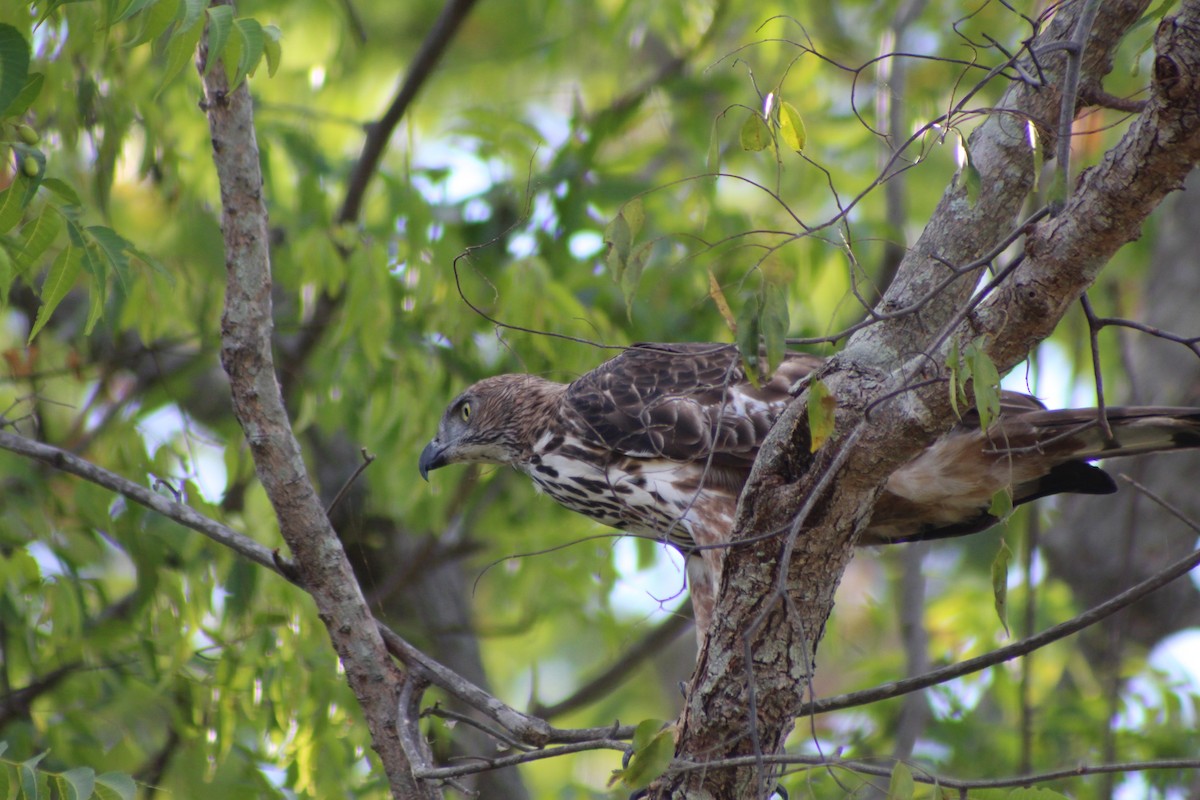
[650, 1, 1200, 799]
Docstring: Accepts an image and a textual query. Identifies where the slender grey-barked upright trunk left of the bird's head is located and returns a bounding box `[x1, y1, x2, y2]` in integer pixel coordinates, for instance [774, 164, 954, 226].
[197, 7, 440, 800]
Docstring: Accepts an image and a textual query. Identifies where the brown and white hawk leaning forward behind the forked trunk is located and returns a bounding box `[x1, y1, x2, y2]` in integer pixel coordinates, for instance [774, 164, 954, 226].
[420, 343, 1200, 639]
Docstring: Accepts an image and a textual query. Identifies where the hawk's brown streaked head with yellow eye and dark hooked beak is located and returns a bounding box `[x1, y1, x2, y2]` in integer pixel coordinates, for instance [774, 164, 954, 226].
[419, 375, 564, 480]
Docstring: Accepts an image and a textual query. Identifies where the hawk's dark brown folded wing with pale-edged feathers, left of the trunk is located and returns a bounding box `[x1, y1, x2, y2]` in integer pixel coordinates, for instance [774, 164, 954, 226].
[566, 343, 822, 471]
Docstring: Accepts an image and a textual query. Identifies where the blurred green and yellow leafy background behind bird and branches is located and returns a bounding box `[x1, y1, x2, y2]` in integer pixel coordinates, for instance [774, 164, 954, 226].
[0, 0, 1198, 798]
